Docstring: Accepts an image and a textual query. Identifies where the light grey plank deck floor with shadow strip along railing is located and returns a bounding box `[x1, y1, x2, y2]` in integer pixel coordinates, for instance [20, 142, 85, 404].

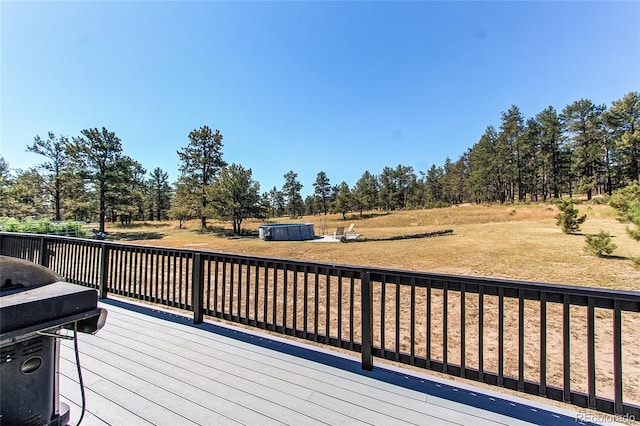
[60, 300, 596, 426]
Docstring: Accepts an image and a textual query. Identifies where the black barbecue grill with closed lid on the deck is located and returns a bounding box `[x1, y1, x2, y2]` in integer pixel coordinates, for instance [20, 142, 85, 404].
[0, 256, 107, 426]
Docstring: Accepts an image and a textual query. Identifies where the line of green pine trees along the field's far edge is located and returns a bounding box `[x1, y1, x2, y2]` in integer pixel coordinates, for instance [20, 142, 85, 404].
[0, 92, 640, 233]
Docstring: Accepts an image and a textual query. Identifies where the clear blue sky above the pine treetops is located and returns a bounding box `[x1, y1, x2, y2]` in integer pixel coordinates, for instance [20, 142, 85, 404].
[0, 0, 640, 195]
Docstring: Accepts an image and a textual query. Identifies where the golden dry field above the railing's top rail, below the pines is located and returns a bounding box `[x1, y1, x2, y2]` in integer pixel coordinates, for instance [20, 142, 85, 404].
[107, 204, 640, 290]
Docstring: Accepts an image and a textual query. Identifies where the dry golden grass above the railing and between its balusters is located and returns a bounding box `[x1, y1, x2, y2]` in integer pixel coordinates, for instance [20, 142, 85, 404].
[101, 204, 640, 416]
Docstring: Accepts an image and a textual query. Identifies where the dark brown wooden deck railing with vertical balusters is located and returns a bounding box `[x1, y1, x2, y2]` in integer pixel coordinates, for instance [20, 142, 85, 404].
[0, 233, 640, 419]
